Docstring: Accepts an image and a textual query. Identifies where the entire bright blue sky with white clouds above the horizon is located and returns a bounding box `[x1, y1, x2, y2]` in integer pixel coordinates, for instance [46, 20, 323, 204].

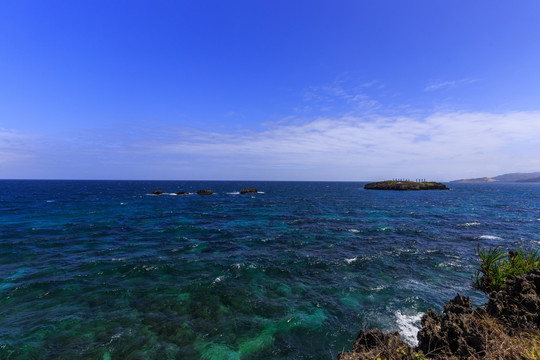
[0, 0, 540, 181]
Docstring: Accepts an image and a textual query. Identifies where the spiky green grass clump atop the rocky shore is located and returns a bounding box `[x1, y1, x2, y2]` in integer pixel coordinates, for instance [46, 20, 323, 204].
[474, 247, 540, 293]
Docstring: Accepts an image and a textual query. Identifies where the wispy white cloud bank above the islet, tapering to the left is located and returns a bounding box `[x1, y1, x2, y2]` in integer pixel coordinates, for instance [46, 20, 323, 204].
[141, 112, 540, 180]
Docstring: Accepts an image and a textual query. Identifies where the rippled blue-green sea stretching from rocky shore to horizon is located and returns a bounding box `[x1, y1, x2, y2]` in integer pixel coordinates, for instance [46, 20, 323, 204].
[0, 180, 540, 360]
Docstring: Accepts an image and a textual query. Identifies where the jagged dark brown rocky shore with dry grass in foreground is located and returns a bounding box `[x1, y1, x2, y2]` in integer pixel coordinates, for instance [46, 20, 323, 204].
[338, 269, 540, 360]
